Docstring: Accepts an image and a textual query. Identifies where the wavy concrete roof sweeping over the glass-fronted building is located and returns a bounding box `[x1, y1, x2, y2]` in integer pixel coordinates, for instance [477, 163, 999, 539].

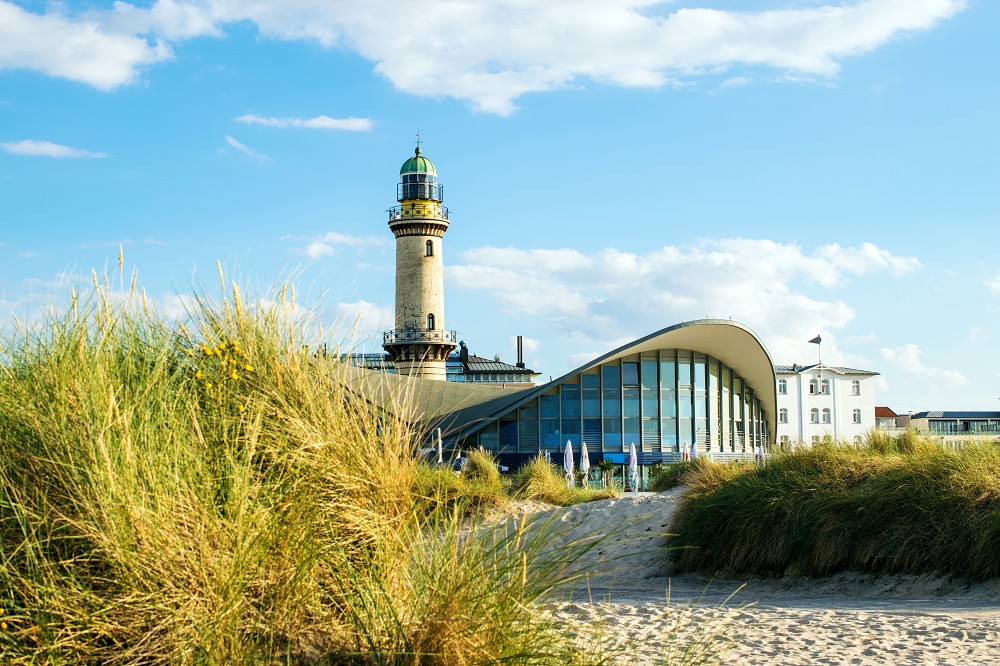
[349, 319, 777, 444]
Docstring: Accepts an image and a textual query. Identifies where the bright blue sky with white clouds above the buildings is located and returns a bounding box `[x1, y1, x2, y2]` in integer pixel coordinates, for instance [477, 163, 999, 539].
[0, 0, 1000, 413]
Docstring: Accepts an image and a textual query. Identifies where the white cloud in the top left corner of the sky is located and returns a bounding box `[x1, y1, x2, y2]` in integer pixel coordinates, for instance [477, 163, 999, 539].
[0, 0, 171, 90]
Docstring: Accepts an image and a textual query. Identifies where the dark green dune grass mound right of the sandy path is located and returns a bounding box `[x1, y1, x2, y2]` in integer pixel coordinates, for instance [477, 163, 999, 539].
[670, 433, 1000, 580]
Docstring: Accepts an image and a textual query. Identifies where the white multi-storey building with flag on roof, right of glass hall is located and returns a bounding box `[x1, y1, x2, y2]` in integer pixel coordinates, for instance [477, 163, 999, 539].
[774, 363, 878, 447]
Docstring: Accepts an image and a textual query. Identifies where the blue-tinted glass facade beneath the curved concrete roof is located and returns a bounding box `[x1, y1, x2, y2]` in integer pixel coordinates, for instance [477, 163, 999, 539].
[462, 349, 768, 464]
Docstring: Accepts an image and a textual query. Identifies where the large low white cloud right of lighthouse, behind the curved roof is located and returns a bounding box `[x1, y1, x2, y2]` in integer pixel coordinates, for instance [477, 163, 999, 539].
[446, 239, 920, 362]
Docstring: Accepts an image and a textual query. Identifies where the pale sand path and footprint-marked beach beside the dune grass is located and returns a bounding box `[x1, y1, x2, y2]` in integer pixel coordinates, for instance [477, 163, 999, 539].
[508, 491, 1000, 665]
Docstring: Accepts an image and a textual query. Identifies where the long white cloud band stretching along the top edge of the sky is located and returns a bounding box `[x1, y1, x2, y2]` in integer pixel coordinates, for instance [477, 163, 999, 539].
[0, 0, 967, 114]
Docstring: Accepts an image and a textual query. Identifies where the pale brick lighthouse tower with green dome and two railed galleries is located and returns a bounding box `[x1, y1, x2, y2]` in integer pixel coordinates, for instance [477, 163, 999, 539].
[382, 137, 457, 381]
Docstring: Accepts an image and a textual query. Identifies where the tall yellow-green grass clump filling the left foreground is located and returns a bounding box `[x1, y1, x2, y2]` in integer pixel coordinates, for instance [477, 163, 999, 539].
[0, 275, 608, 664]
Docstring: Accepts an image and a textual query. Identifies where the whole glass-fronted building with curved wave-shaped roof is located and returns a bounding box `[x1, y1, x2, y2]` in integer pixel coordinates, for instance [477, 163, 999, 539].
[353, 319, 777, 474]
